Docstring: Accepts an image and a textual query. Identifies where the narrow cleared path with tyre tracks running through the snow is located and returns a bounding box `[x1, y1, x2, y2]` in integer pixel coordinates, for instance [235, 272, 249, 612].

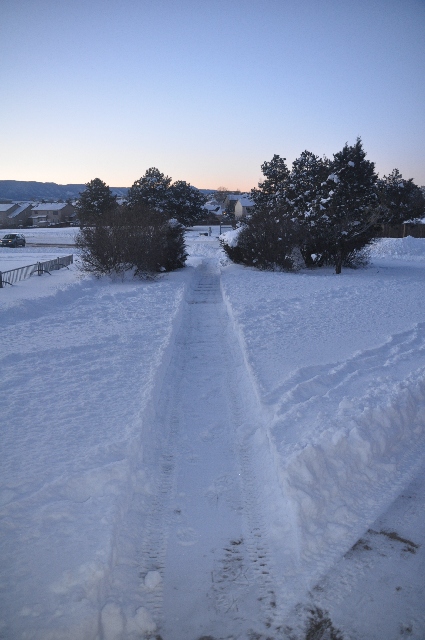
[102, 259, 292, 640]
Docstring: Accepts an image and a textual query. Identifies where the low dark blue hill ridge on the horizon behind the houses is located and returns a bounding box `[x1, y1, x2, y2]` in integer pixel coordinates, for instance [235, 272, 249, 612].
[0, 180, 214, 202]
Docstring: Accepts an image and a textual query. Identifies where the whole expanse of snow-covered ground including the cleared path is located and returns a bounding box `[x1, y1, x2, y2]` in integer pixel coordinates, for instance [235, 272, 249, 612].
[0, 228, 425, 640]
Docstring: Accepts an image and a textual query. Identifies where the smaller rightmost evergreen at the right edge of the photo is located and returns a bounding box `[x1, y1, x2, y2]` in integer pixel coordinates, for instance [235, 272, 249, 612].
[378, 169, 425, 224]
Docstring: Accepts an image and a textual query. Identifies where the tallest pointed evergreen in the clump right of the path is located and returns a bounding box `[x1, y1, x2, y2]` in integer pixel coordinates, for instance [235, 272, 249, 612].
[316, 138, 379, 273]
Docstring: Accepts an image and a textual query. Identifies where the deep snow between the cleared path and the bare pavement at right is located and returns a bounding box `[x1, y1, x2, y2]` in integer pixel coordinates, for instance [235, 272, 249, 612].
[222, 239, 425, 588]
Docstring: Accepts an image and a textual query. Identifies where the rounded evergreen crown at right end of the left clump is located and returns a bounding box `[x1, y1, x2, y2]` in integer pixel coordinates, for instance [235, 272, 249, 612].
[167, 180, 207, 227]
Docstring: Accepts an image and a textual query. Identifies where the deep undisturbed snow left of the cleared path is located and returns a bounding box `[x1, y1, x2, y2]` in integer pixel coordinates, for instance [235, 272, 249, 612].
[0, 267, 190, 640]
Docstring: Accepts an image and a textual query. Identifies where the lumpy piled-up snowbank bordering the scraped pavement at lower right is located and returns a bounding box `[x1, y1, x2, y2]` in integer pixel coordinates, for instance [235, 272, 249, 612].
[278, 347, 425, 585]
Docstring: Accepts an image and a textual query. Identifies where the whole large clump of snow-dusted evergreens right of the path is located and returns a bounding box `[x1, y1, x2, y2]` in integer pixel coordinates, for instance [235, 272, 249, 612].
[223, 138, 425, 273]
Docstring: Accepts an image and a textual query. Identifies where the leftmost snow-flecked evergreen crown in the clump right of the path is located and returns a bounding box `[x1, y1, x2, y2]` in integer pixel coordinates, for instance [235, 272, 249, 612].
[250, 154, 289, 210]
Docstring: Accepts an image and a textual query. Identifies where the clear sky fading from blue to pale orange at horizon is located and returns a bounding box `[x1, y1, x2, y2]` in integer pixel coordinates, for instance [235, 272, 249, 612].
[0, 0, 425, 190]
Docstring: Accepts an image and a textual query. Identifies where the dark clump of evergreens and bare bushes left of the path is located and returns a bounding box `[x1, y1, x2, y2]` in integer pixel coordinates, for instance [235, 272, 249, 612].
[76, 167, 207, 277]
